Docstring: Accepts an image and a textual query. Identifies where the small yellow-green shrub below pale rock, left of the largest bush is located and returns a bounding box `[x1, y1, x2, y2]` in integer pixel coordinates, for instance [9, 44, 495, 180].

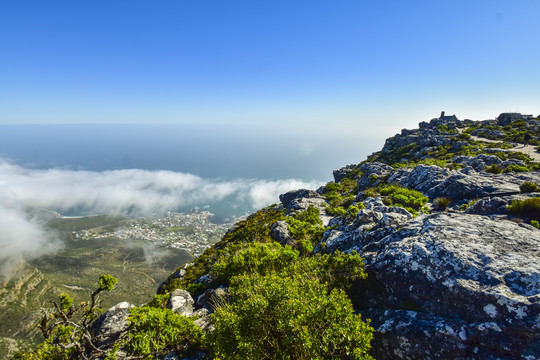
[123, 307, 203, 358]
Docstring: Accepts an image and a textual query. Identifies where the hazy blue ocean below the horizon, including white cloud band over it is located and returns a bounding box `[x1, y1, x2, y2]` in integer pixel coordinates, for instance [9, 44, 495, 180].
[0, 125, 383, 217]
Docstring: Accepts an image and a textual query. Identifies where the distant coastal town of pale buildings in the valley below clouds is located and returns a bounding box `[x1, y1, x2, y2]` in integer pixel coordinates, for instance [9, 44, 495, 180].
[72, 211, 238, 257]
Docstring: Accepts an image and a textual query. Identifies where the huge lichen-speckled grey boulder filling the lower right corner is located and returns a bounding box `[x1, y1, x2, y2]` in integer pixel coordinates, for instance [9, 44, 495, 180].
[354, 213, 540, 359]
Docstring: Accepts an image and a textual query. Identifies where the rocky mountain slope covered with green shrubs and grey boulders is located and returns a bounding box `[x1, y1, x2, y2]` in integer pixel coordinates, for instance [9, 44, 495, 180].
[13, 114, 540, 359]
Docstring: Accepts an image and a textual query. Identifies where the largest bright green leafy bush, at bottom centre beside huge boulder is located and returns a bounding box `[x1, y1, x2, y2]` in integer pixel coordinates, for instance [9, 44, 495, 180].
[208, 274, 373, 360]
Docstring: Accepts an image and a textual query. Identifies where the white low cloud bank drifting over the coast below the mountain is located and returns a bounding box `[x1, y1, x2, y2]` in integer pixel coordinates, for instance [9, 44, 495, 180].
[0, 159, 320, 280]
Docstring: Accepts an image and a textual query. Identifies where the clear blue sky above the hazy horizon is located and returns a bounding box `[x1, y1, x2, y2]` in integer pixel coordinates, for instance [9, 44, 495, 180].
[0, 0, 540, 128]
